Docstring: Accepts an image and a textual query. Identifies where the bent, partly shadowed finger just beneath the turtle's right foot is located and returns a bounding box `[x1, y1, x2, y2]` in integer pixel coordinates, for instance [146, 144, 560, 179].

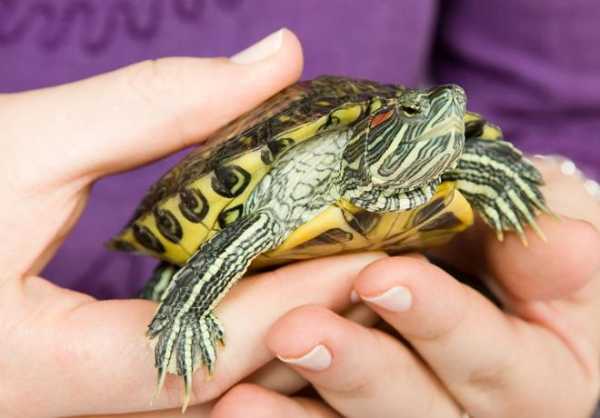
[431, 216, 600, 303]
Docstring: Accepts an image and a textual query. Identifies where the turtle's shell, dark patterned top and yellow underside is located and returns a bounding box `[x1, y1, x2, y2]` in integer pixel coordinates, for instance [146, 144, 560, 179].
[109, 76, 494, 267]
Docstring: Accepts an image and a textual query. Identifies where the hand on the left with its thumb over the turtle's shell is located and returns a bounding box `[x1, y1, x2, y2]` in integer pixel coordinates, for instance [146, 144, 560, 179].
[0, 31, 378, 417]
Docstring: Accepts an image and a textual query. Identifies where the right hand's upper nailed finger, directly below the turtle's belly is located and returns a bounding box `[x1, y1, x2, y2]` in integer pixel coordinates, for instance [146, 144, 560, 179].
[355, 257, 593, 417]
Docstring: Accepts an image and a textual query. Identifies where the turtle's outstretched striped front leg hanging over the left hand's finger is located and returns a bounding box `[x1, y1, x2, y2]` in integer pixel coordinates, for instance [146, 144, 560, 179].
[147, 214, 280, 410]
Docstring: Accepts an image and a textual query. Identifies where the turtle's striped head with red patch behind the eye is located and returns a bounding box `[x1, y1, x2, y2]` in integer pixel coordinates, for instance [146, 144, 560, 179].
[342, 85, 466, 211]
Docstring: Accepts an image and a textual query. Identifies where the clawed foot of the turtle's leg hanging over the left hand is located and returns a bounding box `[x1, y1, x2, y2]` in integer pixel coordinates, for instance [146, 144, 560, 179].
[147, 310, 225, 412]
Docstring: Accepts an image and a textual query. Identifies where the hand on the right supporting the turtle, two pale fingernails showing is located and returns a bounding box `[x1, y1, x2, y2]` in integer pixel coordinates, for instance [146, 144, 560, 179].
[212, 158, 600, 418]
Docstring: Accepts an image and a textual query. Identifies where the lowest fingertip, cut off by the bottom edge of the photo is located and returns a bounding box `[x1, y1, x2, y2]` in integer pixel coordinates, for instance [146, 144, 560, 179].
[211, 384, 341, 418]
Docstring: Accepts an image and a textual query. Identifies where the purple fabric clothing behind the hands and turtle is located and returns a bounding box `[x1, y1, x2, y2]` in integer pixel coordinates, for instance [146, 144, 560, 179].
[0, 0, 600, 298]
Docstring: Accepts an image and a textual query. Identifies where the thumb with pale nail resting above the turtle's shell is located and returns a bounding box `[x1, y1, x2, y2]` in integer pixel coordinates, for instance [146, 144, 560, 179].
[0, 30, 302, 185]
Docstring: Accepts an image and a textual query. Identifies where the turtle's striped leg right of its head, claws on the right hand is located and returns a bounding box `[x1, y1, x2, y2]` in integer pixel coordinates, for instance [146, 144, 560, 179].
[443, 138, 550, 245]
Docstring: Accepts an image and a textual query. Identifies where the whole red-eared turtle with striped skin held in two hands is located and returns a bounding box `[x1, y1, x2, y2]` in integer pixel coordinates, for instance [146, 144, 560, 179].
[109, 76, 548, 409]
